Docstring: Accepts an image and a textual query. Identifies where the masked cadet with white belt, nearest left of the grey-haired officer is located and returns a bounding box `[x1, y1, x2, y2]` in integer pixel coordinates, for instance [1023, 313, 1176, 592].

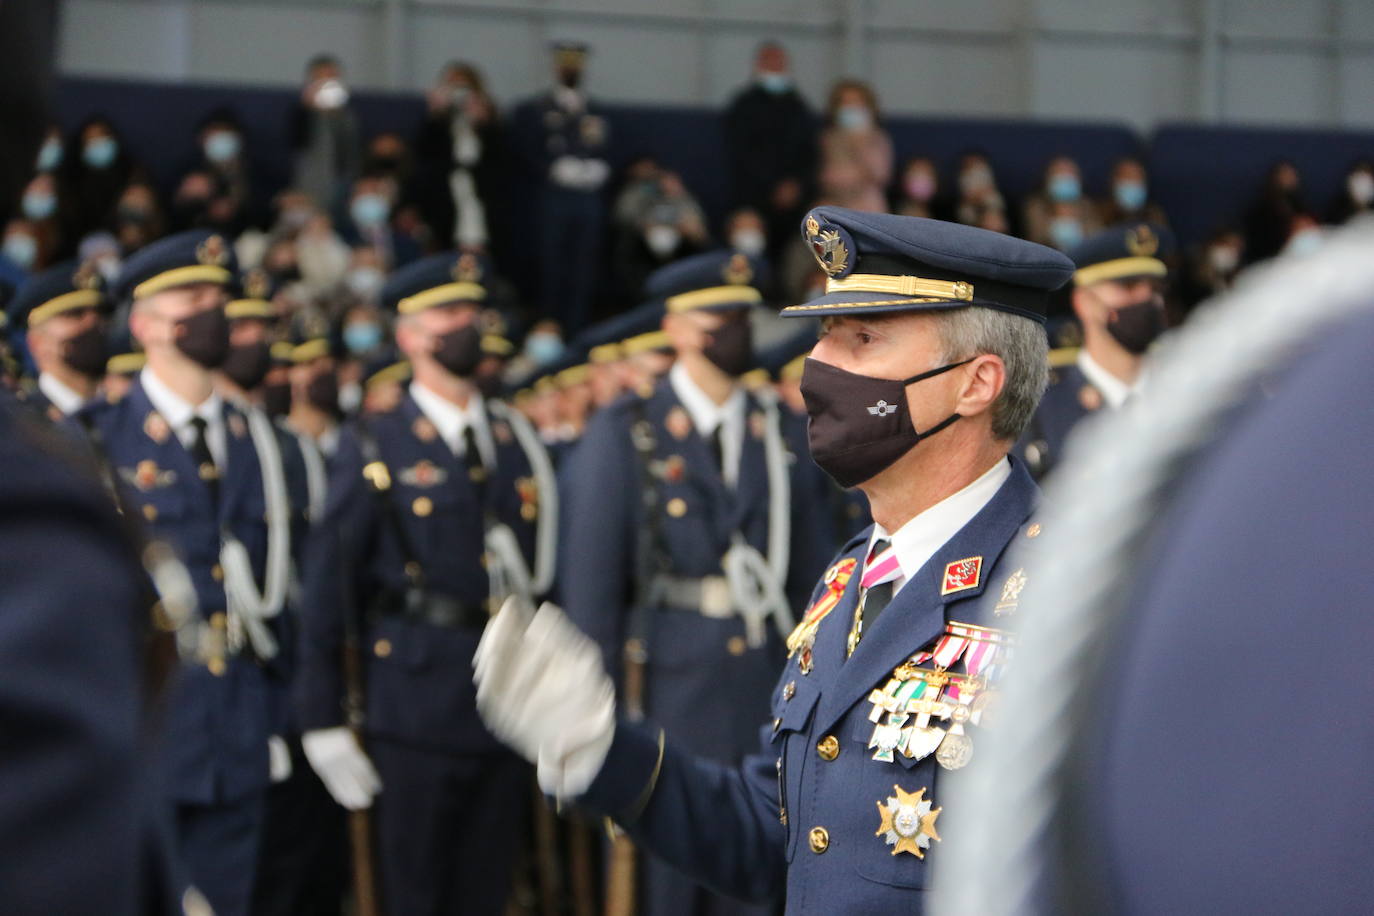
[559, 251, 835, 915]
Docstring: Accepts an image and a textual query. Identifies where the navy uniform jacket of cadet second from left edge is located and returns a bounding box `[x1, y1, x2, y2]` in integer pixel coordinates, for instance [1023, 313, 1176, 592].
[87, 380, 281, 805]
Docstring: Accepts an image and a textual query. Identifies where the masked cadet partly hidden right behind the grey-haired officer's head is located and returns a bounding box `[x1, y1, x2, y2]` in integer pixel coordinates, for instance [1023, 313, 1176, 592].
[1017, 222, 1173, 478]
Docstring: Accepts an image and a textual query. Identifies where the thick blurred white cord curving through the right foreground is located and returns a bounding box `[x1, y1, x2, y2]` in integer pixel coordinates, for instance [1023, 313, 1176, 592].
[932, 218, 1374, 916]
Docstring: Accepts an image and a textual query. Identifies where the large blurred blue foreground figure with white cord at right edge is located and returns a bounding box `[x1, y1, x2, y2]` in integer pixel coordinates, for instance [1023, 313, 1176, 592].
[936, 221, 1374, 916]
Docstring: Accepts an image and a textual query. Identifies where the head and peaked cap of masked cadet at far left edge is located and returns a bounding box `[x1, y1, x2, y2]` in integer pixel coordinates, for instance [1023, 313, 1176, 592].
[10, 261, 106, 422]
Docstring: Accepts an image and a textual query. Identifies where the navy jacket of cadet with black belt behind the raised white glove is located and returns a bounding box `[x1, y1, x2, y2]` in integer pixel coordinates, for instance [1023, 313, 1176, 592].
[297, 394, 539, 754]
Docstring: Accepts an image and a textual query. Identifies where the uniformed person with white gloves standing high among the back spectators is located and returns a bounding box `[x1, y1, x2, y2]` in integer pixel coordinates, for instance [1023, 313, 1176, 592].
[514, 41, 610, 335]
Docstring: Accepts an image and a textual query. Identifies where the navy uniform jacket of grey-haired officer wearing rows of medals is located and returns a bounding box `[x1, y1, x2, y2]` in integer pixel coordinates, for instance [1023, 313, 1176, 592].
[581, 461, 1039, 913]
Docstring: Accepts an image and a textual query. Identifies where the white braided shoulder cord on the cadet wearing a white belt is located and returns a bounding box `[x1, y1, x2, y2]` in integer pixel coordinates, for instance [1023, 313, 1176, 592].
[721, 393, 793, 648]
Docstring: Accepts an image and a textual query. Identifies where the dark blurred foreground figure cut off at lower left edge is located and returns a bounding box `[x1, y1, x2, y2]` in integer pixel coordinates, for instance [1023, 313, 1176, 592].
[0, 397, 166, 915]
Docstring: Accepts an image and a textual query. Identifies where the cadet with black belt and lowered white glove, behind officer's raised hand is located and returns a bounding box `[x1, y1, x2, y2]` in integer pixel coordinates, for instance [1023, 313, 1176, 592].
[298, 253, 556, 916]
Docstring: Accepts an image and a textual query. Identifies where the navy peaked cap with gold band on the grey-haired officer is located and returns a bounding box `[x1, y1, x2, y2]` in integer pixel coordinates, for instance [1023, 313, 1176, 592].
[782, 207, 1073, 321]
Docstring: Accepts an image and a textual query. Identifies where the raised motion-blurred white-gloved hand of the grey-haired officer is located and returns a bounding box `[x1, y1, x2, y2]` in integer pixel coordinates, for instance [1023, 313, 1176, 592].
[473, 597, 616, 798]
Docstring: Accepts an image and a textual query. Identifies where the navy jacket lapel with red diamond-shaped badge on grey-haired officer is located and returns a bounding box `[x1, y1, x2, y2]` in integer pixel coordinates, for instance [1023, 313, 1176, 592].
[816, 461, 1039, 729]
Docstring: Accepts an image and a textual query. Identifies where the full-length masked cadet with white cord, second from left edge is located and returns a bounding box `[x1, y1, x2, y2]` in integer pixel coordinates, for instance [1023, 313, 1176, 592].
[81, 231, 293, 915]
